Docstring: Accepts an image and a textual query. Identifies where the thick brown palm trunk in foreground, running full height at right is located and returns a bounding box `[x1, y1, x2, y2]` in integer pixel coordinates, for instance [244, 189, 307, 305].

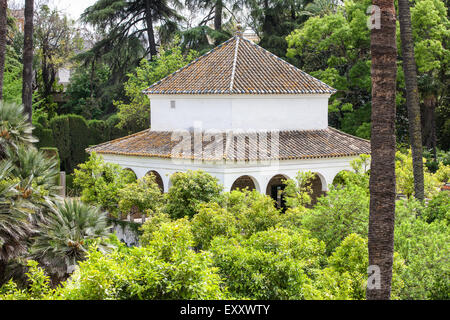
[366, 0, 397, 300]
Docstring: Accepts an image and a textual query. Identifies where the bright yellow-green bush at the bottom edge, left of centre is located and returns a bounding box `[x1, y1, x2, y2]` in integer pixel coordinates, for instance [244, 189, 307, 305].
[58, 242, 226, 300]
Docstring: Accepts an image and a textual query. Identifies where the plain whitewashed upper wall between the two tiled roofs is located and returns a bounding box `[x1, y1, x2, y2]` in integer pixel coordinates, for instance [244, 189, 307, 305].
[150, 94, 329, 131]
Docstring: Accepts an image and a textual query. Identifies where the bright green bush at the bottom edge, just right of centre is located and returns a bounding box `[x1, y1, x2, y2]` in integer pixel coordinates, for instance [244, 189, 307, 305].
[211, 237, 312, 300]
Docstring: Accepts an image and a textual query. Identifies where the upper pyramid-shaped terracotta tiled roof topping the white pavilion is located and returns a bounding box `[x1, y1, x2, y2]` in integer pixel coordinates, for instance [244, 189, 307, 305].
[144, 35, 336, 94]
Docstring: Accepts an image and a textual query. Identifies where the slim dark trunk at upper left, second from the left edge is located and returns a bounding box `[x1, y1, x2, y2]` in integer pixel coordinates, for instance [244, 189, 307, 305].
[22, 0, 34, 122]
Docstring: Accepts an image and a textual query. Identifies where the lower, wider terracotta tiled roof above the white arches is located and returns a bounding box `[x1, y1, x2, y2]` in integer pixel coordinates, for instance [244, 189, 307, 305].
[86, 127, 370, 161]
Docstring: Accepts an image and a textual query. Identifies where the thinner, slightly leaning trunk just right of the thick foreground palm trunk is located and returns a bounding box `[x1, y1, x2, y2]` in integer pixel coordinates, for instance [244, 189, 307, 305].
[398, 0, 425, 201]
